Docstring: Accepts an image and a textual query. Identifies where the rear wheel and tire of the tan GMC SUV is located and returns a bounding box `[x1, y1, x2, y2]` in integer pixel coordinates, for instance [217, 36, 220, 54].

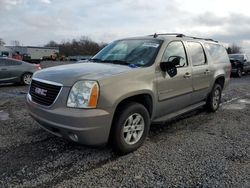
[206, 84, 222, 112]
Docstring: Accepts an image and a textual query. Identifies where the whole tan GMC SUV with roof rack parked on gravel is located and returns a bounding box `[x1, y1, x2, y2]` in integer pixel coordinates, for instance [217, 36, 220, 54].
[26, 34, 231, 154]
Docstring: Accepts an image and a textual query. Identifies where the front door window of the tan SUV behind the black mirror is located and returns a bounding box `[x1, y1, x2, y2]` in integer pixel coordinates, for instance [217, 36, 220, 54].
[162, 41, 188, 67]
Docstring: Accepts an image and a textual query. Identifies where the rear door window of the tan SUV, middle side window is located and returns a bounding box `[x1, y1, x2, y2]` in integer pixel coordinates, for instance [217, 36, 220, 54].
[188, 42, 206, 66]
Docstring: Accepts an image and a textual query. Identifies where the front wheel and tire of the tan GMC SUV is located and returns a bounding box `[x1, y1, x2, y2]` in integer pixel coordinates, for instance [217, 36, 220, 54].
[111, 102, 151, 154]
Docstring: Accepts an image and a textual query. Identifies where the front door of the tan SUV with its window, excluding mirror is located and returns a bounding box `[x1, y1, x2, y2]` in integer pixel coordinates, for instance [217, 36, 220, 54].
[157, 41, 193, 117]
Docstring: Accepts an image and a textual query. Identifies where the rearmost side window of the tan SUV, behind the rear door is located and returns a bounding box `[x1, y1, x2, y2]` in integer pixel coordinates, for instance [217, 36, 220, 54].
[205, 43, 229, 63]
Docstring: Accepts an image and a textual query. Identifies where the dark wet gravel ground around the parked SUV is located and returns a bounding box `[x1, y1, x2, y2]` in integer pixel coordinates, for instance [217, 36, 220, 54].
[0, 70, 250, 187]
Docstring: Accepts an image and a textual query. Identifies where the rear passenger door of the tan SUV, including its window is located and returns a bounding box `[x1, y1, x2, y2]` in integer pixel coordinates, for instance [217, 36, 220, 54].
[187, 41, 212, 103]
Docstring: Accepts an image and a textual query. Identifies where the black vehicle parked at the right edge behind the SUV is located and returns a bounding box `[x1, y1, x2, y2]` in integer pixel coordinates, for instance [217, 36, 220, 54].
[229, 54, 250, 77]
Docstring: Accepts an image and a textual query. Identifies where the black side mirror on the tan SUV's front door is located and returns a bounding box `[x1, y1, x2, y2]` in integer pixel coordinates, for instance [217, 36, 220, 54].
[160, 57, 180, 78]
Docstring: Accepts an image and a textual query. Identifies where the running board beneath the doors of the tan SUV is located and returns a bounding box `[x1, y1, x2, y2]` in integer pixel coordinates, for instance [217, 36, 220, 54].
[152, 101, 206, 123]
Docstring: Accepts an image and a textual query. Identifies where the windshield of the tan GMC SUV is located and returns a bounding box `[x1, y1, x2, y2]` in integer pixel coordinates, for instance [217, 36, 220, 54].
[90, 39, 162, 67]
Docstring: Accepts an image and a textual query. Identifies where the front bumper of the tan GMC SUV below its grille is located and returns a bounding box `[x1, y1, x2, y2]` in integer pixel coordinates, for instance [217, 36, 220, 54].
[26, 94, 113, 145]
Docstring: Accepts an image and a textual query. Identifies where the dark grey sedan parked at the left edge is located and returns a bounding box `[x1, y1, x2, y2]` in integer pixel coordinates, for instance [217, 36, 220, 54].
[0, 57, 41, 85]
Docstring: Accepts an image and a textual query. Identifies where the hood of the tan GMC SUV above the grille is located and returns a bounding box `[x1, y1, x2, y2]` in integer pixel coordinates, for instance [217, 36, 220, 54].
[33, 62, 133, 86]
